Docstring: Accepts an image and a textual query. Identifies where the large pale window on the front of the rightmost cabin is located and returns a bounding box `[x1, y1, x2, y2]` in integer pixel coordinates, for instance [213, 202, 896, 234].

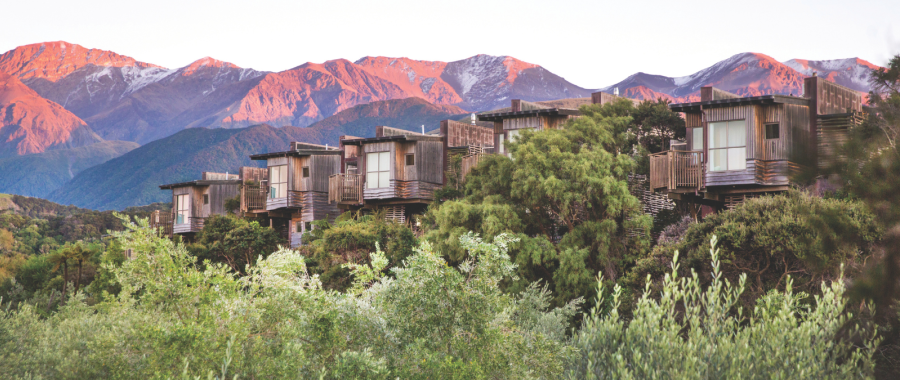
[709, 120, 747, 171]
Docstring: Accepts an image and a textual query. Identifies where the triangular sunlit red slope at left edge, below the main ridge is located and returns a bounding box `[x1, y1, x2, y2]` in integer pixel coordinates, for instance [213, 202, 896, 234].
[0, 71, 102, 157]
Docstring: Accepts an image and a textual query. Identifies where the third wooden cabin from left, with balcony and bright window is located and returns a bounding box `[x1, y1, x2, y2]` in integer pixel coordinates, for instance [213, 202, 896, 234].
[328, 126, 445, 223]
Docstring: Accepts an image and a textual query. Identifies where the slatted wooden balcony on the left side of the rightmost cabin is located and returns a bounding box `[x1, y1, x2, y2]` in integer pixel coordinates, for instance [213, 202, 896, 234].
[650, 150, 703, 193]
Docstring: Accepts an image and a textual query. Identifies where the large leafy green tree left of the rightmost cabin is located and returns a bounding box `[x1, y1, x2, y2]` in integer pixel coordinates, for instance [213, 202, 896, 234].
[425, 102, 651, 304]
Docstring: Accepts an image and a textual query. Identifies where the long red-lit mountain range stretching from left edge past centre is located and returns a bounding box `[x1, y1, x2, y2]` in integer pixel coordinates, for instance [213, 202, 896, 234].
[0, 42, 590, 144]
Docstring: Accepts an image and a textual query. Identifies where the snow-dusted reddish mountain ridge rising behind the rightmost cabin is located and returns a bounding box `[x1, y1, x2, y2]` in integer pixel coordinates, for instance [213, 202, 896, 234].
[601, 53, 878, 102]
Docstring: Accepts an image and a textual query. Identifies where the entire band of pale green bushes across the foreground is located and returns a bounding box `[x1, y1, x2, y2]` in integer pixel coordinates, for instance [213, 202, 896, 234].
[0, 215, 877, 379]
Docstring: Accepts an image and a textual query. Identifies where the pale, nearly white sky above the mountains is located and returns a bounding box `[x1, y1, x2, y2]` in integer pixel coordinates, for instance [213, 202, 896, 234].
[0, 0, 900, 88]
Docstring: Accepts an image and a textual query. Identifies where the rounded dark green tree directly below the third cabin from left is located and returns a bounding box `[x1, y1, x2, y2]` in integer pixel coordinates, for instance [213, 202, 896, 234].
[299, 212, 418, 290]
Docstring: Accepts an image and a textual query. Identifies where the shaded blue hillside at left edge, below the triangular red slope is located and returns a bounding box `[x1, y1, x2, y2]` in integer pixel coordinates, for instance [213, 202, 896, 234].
[0, 141, 140, 197]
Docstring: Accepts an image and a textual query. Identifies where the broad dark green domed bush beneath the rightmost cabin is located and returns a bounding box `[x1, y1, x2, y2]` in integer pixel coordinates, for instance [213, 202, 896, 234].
[623, 191, 883, 300]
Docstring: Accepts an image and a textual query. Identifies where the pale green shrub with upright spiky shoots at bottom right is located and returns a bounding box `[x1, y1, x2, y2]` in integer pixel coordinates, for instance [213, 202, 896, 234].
[566, 235, 878, 379]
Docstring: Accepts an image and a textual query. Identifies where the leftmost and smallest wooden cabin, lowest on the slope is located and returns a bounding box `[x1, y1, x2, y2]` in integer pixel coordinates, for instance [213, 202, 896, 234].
[157, 172, 242, 234]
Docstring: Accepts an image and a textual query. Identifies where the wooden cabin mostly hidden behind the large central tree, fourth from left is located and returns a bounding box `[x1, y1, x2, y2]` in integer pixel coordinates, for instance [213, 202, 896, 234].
[477, 92, 638, 155]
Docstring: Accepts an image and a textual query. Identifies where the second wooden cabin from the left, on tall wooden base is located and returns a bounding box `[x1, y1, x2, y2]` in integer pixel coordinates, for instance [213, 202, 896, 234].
[248, 142, 343, 247]
